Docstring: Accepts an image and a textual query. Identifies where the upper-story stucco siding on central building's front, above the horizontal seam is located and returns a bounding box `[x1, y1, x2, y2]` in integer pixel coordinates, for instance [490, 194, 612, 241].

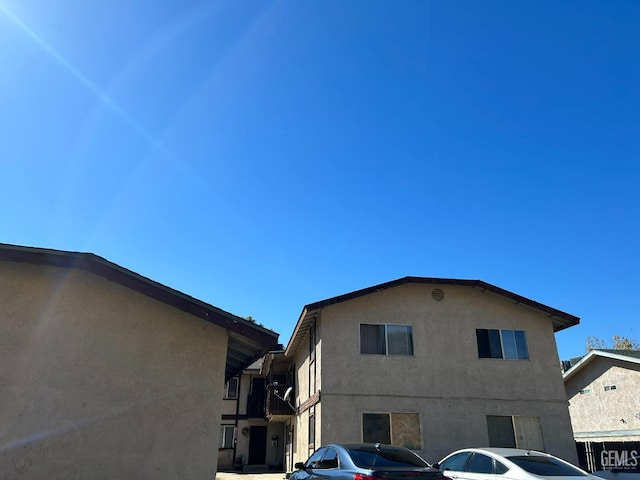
[322, 284, 566, 400]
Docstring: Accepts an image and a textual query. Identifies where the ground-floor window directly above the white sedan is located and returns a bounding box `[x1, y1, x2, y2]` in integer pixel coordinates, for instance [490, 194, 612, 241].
[487, 415, 544, 451]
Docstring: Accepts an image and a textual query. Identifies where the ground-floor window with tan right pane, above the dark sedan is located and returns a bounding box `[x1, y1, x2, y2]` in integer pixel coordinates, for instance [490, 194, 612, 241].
[362, 412, 422, 450]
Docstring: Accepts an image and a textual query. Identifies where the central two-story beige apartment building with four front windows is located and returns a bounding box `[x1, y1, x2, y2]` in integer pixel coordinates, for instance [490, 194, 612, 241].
[264, 277, 579, 470]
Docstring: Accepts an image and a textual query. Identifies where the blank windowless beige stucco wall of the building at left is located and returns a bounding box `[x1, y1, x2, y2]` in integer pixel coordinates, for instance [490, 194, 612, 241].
[0, 262, 227, 479]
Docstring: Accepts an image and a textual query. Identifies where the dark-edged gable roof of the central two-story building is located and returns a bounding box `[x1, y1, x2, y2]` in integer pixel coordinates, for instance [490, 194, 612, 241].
[286, 277, 580, 356]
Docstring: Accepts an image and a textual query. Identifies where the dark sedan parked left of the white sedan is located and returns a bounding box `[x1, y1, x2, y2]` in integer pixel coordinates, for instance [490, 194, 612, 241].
[289, 443, 449, 480]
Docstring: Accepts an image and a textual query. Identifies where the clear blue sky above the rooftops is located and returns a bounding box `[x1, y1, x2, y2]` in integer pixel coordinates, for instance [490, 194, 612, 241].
[0, 0, 640, 358]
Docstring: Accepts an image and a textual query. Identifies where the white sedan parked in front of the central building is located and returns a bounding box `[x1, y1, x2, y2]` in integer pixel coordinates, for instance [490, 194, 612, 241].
[434, 448, 601, 480]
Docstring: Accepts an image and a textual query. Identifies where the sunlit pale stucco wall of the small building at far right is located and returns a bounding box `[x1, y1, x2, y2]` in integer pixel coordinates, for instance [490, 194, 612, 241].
[566, 357, 640, 441]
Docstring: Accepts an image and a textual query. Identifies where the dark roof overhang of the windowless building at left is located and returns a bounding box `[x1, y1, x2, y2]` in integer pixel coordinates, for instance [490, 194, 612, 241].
[0, 243, 278, 380]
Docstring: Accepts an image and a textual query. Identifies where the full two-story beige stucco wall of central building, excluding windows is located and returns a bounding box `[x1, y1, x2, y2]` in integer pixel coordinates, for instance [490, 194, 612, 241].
[296, 284, 577, 462]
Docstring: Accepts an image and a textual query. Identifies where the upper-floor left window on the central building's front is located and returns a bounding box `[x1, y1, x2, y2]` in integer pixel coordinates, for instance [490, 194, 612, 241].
[360, 323, 413, 355]
